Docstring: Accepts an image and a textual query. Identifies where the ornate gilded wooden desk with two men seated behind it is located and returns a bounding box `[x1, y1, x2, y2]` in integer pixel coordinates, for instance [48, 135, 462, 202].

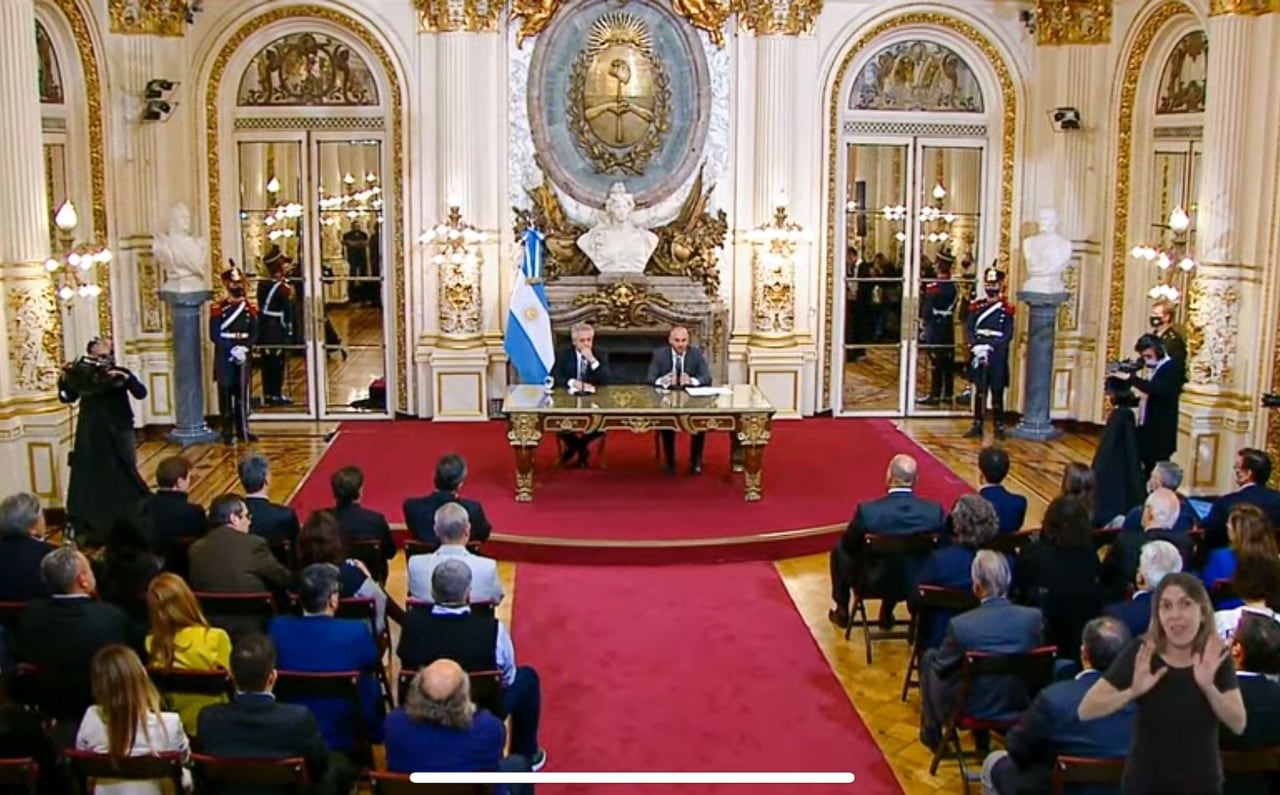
[502, 384, 776, 502]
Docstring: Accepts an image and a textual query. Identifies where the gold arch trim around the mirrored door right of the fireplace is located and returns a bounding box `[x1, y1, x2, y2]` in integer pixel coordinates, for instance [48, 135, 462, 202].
[819, 12, 1018, 406]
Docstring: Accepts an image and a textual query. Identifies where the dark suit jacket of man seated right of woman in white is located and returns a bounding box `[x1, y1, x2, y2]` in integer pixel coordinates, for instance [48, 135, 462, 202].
[193, 693, 329, 795]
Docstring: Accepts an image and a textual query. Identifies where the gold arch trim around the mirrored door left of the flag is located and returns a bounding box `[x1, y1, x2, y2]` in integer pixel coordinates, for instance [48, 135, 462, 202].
[206, 6, 410, 412]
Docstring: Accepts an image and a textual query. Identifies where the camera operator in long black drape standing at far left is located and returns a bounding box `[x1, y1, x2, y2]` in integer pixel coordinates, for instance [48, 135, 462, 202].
[58, 339, 151, 544]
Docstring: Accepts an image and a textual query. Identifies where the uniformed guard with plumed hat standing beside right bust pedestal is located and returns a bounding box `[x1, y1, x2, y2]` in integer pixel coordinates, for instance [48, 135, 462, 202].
[965, 265, 1014, 439]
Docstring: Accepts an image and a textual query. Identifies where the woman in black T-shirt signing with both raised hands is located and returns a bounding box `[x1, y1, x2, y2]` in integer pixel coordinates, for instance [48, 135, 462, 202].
[1078, 574, 1245, 795]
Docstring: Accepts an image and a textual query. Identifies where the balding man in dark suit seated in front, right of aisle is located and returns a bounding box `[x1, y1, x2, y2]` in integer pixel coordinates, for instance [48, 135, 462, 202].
[827, 454, 947, 627]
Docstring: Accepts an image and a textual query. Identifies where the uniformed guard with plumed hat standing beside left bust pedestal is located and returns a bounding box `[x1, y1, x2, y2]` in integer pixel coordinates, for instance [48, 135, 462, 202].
[209, 264, 257, 444]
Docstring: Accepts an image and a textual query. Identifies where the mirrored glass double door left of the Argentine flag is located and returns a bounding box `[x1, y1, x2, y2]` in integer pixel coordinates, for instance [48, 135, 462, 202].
[237, 132, 390, 419]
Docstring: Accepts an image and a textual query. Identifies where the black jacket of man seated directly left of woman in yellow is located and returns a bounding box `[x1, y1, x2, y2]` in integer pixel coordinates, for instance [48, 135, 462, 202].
[18, 597, 147, 723]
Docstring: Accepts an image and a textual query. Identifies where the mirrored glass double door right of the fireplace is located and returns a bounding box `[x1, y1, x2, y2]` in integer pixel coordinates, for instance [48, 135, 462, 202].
[835, 137, 986, 416]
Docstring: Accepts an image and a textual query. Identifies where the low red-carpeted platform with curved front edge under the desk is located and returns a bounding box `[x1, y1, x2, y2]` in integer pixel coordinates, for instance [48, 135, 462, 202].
[292, 419, 968, 563]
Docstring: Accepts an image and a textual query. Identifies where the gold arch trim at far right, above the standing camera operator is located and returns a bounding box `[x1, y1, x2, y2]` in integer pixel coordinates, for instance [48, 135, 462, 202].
[1106, 1, 1192, 361]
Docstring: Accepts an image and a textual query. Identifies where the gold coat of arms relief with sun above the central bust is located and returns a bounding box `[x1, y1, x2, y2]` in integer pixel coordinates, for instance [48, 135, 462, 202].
[567, 12, 671, 177]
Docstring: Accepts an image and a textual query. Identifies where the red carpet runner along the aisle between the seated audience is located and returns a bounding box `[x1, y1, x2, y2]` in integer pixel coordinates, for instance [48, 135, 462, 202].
[513, 562, 902, 795]
